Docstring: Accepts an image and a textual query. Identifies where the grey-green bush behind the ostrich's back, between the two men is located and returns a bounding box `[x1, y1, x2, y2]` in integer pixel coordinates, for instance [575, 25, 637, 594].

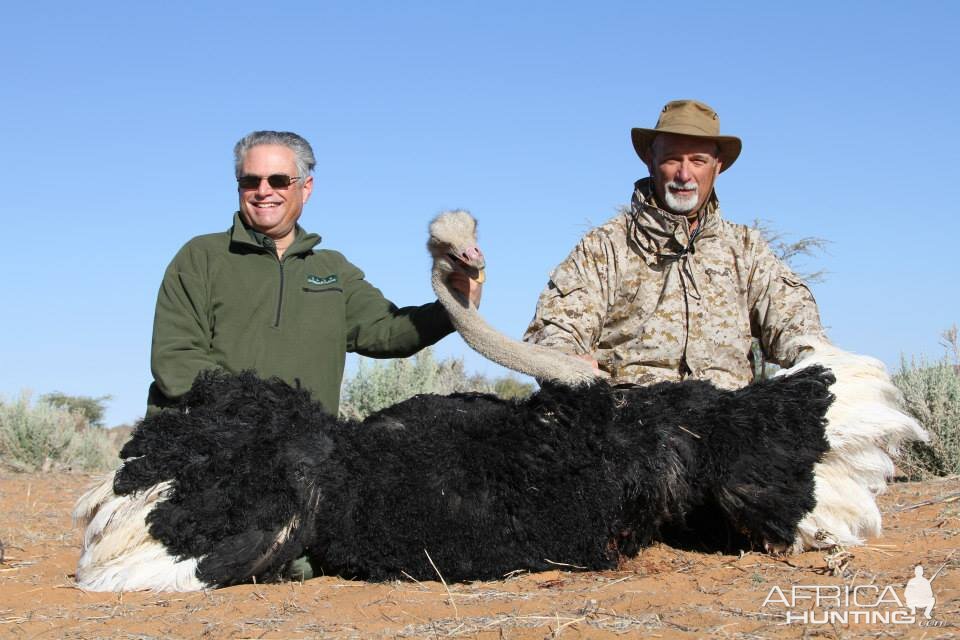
[340, 348, 534, 420]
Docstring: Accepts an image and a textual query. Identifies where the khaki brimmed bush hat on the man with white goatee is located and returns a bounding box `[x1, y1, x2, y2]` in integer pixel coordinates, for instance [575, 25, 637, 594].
[630, 100, 743, 173]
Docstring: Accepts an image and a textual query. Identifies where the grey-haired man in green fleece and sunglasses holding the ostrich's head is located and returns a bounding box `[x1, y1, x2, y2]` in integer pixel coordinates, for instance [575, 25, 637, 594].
[147, 131, 481, 580]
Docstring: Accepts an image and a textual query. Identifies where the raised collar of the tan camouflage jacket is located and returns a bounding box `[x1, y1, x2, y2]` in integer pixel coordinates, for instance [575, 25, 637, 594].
[627, 178, 720, 265]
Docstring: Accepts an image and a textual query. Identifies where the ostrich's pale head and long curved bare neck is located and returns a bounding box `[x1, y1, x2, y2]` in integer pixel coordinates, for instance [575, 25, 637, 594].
[427, 210, 598, 386]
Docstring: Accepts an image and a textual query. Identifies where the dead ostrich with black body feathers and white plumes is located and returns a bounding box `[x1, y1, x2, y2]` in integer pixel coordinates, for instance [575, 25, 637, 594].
[74, 211, 923, 591]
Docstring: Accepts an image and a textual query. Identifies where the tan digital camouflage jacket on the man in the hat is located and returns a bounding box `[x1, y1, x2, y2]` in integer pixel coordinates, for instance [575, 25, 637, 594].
[524, 178, 825, 388]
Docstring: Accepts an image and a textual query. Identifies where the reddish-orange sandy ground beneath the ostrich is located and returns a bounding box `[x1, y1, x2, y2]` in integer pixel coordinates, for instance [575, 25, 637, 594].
[0, 474, 960, 639]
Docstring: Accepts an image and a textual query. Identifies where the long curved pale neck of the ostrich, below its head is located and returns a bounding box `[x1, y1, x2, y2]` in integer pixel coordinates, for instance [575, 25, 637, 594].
[431, 268, 597, 386]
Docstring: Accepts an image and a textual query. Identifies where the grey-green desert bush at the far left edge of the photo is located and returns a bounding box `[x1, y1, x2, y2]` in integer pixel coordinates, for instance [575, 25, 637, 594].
[0, 392, 117, 471]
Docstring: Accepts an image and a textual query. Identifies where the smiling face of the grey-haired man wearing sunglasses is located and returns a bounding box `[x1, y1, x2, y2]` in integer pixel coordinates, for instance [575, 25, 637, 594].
[238, 144, 313, 243]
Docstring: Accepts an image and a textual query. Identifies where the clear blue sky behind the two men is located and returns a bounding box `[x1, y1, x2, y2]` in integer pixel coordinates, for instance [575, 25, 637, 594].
[0, 0, 960, 424]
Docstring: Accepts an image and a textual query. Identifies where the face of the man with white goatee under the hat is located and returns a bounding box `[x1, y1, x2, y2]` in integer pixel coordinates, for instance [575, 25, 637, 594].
[643, 133, 723, 217]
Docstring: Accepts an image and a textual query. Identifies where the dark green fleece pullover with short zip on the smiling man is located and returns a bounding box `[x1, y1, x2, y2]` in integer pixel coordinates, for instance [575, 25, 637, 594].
[147, 213, 453, 414]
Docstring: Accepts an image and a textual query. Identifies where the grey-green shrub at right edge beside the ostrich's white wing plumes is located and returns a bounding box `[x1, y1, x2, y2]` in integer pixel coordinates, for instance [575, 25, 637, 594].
[893, 358, 960, 478]
